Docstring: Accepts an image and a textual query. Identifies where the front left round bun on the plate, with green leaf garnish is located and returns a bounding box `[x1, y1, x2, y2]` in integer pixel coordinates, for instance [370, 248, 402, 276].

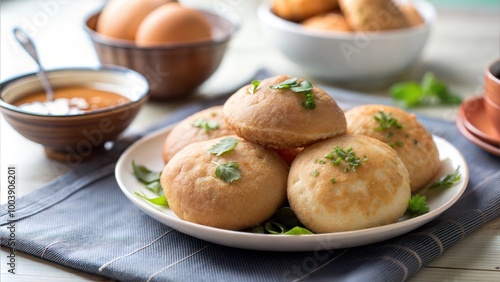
[160, 136, 288, 230]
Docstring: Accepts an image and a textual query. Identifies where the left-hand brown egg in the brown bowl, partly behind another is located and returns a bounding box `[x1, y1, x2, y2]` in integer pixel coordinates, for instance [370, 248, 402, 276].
[96, 0, 172, 40]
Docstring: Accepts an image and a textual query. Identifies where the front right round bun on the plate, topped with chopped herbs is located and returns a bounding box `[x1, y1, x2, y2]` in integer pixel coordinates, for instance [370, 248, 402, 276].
[287, 135, 411, 233]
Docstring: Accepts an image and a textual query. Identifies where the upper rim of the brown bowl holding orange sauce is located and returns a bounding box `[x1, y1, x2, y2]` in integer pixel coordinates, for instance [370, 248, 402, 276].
[0, 65, 149, 119]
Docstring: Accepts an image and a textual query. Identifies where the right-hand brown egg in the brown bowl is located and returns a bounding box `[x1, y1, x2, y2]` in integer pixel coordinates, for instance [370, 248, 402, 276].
[135, 3, 212, 46]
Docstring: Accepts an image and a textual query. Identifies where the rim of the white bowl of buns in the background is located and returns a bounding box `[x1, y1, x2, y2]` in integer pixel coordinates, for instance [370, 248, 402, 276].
[257, 0, 436, 40]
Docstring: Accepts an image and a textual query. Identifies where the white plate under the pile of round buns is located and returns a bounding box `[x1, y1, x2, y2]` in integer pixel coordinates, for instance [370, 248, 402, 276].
[115, 127, 469, 252]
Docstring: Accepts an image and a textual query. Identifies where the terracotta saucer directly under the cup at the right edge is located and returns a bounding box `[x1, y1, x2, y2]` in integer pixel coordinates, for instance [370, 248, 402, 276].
[458, 96, 500, 146]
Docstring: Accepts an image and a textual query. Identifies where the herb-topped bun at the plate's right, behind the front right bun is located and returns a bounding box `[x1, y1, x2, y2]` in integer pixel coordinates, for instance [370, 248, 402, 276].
[345, 105, 440, 192]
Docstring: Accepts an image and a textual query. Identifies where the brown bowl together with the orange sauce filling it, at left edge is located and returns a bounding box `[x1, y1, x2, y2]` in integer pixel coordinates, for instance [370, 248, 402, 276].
[0, 66, 149, 164]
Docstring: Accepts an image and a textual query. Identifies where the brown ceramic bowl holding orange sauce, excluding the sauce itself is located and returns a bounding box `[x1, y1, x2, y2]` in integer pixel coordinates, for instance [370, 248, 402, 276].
[0, 66, 149, 165]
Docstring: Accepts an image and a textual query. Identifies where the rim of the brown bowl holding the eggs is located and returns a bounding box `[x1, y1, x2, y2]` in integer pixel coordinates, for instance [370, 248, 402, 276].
[83, 7, 241, 50]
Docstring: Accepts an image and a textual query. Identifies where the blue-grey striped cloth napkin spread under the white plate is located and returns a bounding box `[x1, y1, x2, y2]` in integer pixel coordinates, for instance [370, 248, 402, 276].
[0, 71, 500, 282]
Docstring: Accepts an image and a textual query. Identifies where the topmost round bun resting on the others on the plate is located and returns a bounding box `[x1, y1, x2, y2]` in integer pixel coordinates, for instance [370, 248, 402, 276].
[224, 75, 346, 149]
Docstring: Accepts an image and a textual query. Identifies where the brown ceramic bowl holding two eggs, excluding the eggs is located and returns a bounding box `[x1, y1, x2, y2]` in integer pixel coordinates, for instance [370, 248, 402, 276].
[84, 11, 238, 100]
